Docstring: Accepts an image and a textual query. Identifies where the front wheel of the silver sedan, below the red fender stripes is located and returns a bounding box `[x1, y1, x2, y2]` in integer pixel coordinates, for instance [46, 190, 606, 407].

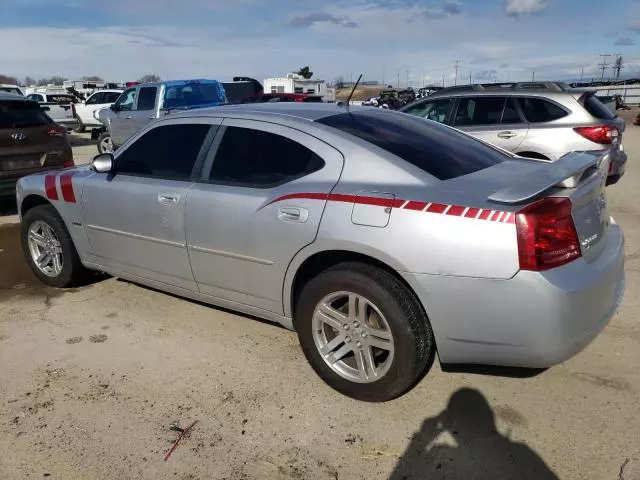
[20, 205, 89, 288]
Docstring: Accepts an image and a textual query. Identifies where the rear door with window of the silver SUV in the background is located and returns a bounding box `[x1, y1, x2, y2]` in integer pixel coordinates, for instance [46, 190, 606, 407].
[453, 96, 529, 152]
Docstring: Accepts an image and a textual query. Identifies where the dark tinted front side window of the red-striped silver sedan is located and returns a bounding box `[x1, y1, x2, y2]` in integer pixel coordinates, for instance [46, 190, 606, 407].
[116, 124, 211, 180]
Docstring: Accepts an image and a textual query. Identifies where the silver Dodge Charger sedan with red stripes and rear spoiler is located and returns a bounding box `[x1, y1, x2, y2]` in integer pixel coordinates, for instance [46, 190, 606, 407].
[17, 104, 624, 401]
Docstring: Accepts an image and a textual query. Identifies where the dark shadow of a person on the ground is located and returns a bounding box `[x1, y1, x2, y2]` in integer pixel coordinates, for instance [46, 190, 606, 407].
[389, 388, 558, 480]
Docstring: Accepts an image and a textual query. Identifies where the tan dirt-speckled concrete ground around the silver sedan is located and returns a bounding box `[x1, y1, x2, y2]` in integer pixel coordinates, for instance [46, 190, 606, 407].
[0, 124, 640, 480]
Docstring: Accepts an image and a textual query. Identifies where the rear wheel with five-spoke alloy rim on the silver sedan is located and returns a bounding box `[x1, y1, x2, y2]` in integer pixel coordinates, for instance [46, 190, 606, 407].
[295, 262, 435, 402]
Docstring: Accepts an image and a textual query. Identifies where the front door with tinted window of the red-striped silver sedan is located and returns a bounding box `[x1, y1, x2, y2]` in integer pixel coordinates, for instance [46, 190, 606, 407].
[82, 119, 213, 290]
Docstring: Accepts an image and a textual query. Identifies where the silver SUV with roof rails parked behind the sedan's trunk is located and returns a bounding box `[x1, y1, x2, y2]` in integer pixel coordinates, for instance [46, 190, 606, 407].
[400, 82, 627, 185]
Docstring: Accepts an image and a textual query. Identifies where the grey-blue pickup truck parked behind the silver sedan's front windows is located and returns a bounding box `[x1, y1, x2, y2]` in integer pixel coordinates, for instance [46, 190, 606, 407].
[96, 80, 226, 153]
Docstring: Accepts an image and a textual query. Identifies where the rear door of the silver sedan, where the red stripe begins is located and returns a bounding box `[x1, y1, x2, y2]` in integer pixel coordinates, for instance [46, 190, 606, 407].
[186, 119, 343, 314]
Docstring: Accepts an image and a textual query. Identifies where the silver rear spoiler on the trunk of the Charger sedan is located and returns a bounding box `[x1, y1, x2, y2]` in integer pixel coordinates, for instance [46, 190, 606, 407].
[488, 152, 606, 204]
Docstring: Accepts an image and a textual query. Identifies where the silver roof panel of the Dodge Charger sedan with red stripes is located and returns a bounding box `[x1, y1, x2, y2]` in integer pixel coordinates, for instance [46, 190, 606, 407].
[171, 103, 350, 121]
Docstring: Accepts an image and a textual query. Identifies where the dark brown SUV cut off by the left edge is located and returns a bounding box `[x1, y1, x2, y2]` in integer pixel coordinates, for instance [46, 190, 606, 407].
[0, 92, 73, 197]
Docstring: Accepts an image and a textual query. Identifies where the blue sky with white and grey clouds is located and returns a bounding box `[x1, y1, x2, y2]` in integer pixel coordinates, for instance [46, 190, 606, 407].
[0, 0, 640, 87]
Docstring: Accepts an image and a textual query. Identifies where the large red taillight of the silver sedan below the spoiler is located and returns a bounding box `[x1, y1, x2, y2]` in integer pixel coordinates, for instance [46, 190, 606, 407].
[516, 197, 582, 272]
